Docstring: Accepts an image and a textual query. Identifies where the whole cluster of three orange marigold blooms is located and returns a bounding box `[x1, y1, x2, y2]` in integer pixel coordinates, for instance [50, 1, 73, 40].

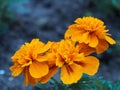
[10, 17, 115, 86]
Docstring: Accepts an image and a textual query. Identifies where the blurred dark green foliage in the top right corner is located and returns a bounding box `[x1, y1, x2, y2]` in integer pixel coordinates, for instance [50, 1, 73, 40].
[91, 0, 120, 16]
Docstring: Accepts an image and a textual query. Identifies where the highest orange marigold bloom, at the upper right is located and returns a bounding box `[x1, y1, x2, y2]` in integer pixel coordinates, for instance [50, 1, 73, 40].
[65, 17, 115, 54]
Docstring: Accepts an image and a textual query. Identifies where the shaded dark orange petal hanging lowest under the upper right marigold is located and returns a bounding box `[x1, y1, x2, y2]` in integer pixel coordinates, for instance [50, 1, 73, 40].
[96, 40, 109, 54]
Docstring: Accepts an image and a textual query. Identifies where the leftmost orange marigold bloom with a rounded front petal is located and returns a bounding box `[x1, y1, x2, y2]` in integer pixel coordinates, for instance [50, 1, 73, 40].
[10, 39, 51, 86]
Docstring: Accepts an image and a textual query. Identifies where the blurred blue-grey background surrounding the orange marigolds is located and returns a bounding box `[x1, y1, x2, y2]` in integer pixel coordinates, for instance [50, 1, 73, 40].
[0, 0, 120, 90]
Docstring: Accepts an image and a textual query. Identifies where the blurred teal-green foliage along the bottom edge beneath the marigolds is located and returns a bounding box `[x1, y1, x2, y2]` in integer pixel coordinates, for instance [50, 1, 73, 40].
[37, 74, 120, 90]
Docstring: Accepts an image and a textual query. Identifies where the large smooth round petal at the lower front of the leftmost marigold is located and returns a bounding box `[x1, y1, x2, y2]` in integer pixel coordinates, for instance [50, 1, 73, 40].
[29, 61, 49, 78]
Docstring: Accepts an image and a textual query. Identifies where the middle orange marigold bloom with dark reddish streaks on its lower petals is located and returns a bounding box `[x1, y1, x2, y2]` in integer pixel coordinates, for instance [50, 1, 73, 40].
[40, 40, 99, 84]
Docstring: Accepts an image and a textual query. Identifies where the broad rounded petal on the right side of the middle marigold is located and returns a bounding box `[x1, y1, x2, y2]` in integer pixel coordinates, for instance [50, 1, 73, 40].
[80, 56, 99, 75]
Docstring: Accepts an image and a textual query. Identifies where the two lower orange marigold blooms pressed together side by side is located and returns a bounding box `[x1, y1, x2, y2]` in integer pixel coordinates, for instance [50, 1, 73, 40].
[10, 39, 99, 86]
